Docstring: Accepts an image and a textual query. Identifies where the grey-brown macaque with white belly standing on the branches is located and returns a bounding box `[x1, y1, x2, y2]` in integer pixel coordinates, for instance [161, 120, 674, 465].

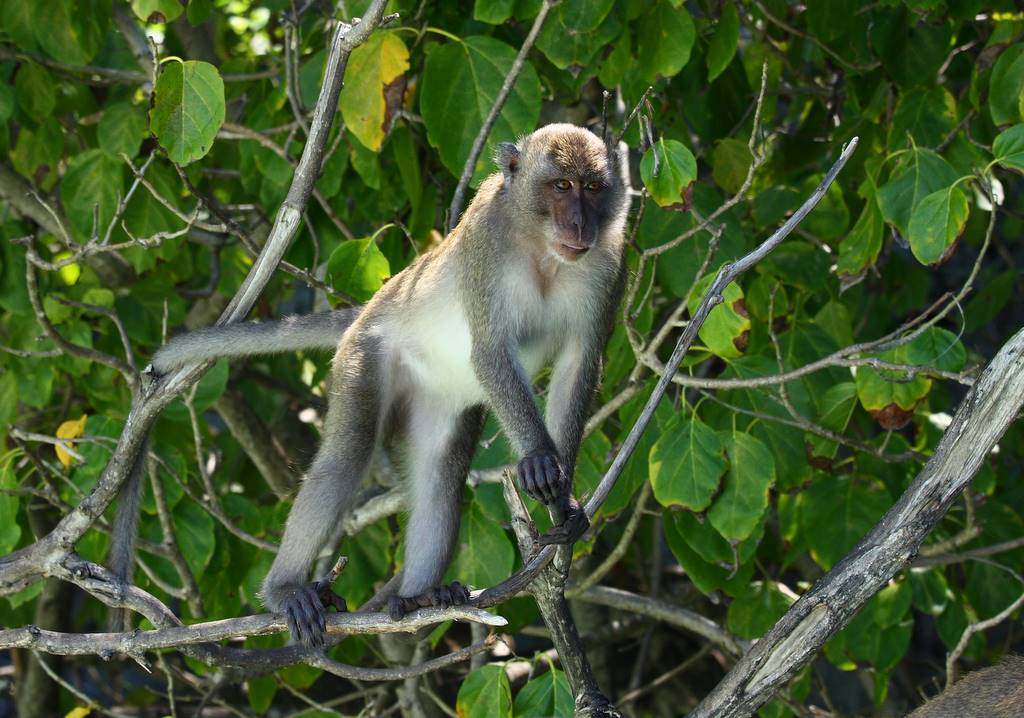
[143, 124, 629, 646]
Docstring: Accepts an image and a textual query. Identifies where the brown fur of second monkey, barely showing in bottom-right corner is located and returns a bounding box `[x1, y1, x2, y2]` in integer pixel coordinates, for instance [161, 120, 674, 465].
[907, 656, 1024, 718]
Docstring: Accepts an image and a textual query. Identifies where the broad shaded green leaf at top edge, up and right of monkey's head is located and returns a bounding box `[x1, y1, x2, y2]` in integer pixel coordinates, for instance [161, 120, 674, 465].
[637, 0, 696, 83]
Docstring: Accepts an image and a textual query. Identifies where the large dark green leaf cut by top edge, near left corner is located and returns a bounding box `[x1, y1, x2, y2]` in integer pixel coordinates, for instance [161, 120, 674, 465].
[35, 0, 111, 65]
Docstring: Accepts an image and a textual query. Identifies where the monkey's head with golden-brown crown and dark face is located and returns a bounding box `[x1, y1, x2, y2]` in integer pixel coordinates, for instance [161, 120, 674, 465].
[497, 124, 628, 262]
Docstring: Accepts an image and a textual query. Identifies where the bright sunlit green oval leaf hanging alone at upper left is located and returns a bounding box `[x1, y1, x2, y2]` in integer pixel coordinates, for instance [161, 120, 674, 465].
[150, 59, 224, 165]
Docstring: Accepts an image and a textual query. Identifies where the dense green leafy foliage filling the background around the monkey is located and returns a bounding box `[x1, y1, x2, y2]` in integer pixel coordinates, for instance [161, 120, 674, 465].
[0, 0, 1024, 716]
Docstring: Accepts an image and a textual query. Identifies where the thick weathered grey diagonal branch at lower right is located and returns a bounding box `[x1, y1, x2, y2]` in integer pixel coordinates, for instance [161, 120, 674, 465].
[692, 330, 1024, 718]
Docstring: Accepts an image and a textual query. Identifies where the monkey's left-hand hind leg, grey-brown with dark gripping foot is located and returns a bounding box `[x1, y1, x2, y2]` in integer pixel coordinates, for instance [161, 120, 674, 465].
[262, 336, 388, 647]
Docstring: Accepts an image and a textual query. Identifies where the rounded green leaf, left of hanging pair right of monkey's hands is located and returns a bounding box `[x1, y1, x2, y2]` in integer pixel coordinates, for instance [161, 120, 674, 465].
[650, 414, 726, 511]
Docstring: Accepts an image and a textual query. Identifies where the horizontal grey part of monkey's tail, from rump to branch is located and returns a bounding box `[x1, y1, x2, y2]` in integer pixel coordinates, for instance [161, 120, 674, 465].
[152, 306, 361, 374]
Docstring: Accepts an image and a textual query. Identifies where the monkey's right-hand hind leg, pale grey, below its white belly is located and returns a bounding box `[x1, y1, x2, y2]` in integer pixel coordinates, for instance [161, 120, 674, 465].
[388, 396, 483, 621]
